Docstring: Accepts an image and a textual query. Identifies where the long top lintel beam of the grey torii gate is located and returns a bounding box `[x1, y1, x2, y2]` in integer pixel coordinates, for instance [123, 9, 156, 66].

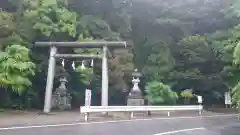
[35, 40, 127, 48]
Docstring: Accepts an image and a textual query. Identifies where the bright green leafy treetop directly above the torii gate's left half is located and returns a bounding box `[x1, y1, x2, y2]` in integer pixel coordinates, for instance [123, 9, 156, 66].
[23, 0, 78, 40]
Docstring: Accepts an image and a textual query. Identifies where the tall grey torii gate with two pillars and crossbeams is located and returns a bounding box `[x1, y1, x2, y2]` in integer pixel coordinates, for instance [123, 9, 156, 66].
[35, 41, 127, 113]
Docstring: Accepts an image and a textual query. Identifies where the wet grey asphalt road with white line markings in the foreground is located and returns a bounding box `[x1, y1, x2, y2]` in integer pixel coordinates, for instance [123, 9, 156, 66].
[0, 115, 240, 135]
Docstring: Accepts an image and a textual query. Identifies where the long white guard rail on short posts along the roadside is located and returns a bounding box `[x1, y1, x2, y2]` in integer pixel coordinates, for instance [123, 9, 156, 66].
[80, 105, 203, 121]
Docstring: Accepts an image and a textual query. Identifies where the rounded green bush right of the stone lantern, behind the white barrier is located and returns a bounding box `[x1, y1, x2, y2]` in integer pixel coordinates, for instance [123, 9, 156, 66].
[145, 81, 178, 105]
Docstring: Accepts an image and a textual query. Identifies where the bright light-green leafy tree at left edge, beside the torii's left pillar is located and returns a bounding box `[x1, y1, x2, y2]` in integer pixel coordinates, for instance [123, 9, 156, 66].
[0, 45, 35, 93]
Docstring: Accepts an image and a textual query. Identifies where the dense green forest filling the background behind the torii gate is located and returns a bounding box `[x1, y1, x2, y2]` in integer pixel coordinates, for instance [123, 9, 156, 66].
[0, 0, 240, 109]
